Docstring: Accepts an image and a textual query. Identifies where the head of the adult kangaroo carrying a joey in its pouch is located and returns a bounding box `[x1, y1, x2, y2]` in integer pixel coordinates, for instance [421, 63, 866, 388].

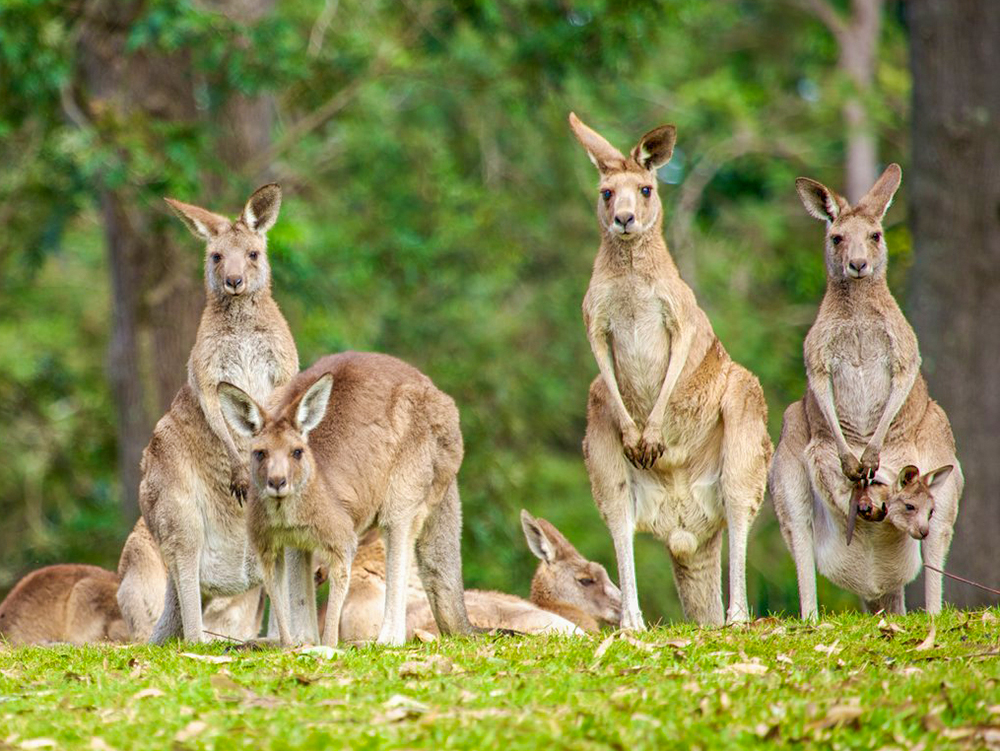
[795, 164, 903, 281]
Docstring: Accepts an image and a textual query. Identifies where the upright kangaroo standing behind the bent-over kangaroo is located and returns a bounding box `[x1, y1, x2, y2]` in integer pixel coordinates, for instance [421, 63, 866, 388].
[139, 185, 298, 644]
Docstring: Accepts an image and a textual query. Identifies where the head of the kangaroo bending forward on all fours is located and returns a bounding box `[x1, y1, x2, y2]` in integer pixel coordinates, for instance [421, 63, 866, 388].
[219, 373, 333, 505]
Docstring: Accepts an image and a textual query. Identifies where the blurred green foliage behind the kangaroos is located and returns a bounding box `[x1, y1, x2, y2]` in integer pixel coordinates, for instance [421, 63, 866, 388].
[0, 0, 911, 620]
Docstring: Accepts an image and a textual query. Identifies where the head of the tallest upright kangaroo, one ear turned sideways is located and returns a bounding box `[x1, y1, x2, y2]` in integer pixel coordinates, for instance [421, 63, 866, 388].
[569, 112, 677, 241]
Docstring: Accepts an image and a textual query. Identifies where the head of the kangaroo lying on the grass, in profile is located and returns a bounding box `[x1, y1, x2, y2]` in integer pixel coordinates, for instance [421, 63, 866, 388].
[521, 510, 622, 624]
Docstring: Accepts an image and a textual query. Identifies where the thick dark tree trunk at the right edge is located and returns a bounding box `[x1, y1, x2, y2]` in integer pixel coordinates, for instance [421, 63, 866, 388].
[907, 0, 1000, 606]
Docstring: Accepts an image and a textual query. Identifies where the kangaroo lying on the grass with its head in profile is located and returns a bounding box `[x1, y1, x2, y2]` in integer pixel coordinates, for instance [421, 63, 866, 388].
[340, 510, 621, 641]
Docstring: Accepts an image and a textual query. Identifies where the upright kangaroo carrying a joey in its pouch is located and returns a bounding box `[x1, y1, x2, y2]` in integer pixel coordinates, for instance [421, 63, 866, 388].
[768, 164, 964, 619]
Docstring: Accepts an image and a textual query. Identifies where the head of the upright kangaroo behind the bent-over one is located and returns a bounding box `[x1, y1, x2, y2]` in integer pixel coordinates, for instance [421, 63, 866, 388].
[166, 183, 281, 298]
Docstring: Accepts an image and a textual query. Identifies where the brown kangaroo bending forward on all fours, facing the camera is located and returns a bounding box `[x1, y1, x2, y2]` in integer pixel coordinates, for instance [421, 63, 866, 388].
[219, 352, 473, 645]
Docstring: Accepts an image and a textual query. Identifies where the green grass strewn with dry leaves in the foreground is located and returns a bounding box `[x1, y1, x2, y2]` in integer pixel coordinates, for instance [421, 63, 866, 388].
[0, 610, 1000, 751]
